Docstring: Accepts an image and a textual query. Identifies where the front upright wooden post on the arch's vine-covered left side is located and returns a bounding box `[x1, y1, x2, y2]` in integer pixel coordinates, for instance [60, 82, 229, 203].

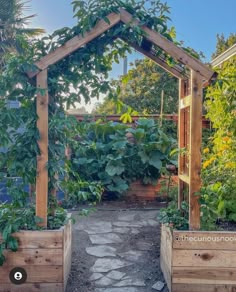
[36, 69, 48, 227]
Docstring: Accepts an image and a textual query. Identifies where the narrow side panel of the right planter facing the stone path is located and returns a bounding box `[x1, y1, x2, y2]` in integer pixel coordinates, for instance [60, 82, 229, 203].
[160, 224, 172, 292]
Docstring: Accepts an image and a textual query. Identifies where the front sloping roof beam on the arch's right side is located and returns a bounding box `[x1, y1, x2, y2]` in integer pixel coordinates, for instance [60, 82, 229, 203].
[120, 9, 214, 80]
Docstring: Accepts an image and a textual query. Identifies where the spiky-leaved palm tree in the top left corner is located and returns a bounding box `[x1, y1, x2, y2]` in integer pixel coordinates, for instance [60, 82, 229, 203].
[0, 0, 44, 67]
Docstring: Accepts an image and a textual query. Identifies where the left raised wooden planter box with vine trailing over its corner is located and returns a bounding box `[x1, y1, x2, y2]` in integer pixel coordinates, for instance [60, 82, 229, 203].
[0, 221, 72, 292]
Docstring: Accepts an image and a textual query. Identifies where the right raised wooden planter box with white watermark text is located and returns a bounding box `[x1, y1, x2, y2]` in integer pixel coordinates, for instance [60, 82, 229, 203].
[161, 225, 236, 292]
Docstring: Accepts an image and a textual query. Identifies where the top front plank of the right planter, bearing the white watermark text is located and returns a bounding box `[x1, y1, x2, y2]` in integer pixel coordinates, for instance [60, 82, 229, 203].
[173, 230, 236, 251]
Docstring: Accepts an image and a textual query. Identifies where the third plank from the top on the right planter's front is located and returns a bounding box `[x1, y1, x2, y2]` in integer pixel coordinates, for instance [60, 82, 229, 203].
[172, 266, 236, 285]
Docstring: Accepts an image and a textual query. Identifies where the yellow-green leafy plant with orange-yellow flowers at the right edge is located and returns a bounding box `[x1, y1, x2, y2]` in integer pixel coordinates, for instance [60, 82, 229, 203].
[201, 57, 236, 228]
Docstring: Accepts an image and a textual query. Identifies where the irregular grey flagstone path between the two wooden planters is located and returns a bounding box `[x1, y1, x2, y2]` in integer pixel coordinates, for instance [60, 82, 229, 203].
[67, 205, 168, 292]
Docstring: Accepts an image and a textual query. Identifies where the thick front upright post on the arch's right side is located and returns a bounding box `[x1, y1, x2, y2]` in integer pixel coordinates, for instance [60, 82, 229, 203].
[189, 70, 203, 230]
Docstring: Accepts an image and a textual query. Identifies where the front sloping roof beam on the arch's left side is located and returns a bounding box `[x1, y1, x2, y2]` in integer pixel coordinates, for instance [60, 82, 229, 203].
[28, 13, 120, 78]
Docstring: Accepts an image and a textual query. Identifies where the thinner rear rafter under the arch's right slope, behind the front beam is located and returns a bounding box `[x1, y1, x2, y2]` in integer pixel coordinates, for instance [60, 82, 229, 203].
[121, 37, 184, 79]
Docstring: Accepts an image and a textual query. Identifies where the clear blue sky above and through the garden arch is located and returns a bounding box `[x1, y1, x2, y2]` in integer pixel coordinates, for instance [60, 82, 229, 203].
[30, 0, 236, 110]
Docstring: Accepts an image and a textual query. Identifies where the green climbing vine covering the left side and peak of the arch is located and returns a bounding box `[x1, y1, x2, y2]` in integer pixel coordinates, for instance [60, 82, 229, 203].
[0, 0, 203, 262]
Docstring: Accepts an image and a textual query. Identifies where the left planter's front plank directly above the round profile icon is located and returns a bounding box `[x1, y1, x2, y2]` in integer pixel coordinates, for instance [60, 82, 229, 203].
[3, 248, 63, 268]
